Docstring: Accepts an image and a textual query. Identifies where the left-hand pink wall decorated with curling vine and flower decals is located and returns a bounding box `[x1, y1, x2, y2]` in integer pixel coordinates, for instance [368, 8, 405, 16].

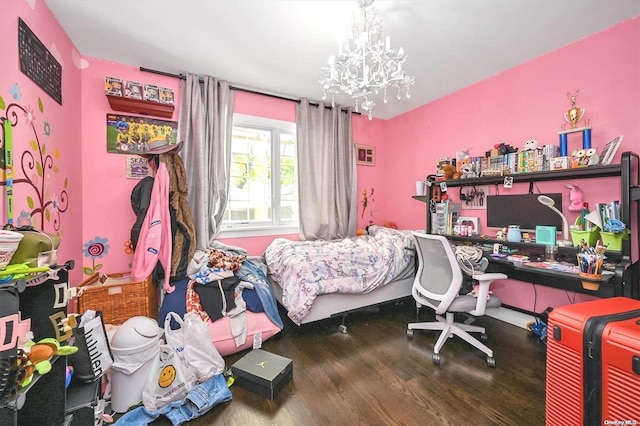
[0, 0, 84, 285]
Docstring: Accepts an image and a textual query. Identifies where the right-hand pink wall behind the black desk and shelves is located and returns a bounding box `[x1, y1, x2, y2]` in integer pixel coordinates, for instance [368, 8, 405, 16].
[380, 18, 640, 312]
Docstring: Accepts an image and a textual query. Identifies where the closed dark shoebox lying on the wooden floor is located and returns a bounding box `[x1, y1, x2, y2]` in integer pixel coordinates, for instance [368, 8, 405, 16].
[231, 349, 293, 399]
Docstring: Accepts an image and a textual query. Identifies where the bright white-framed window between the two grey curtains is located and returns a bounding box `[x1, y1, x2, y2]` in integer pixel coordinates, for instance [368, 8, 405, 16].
[221, 114, 298, 237]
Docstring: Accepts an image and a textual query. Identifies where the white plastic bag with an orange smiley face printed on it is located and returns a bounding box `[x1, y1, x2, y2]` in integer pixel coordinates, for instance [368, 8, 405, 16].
[142, 344, 195, 410]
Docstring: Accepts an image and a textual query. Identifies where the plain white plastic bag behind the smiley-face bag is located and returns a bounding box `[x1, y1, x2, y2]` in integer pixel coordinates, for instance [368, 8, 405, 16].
[164, 312, 224, 383]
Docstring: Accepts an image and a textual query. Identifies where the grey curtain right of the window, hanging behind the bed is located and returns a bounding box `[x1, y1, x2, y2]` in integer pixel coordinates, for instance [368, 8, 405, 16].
[296, 98, 358, 240]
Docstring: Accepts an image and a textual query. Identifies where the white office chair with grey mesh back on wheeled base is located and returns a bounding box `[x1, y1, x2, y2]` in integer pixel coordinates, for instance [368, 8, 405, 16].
[407, 232, 507, 367]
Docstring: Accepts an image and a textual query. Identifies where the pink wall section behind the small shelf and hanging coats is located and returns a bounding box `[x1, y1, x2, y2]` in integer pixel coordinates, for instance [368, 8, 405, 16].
[81, 57, 180, 276]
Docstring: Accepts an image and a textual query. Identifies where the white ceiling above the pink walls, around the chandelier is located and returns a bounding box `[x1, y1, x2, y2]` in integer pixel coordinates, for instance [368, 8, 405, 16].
[44, 0, 640, 119]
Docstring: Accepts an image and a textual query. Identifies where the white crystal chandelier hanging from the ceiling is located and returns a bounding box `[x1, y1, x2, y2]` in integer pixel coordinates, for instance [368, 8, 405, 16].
[319, 0, 415, 120]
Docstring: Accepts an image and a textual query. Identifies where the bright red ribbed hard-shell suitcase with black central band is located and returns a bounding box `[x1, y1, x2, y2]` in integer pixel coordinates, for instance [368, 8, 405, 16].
[545, 297, 640, 426]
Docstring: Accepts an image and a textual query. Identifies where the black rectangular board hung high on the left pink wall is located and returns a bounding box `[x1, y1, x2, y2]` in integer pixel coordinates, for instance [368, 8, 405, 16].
[18, 18, 62, 105]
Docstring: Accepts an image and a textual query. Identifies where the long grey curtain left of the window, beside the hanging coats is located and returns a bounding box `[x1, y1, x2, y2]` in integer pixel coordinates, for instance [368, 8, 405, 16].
[178, 73, 234, 250]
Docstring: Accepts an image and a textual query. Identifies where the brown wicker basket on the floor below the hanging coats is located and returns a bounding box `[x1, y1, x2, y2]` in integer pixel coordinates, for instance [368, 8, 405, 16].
[78, 273, 158, 324]
